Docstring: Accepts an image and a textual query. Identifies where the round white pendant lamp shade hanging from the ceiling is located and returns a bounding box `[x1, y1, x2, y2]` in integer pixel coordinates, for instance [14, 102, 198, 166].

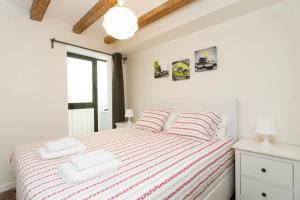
[103, 6, 138, 40]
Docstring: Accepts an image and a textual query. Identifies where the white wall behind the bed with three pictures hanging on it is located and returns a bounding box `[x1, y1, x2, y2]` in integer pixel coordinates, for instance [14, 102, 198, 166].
[126, 0, 300, 144]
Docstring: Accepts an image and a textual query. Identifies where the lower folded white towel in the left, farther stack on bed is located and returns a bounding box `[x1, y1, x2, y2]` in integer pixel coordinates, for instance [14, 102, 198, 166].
[38, 143, 86, 160]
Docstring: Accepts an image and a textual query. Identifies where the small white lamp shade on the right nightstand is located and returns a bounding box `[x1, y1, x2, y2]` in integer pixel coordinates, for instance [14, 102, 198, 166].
[256, 117, 277, 135]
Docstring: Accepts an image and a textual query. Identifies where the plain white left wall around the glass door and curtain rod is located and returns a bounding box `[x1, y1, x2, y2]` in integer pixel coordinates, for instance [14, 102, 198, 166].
[0, 0, 112, 192]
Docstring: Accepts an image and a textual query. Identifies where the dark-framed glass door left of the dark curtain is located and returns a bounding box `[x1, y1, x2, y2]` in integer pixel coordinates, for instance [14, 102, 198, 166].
[67, 53, 98, 135]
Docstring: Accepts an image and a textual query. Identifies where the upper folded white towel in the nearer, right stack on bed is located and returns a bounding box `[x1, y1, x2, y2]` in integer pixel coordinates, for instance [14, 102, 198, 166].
[70, 150, 114, 171]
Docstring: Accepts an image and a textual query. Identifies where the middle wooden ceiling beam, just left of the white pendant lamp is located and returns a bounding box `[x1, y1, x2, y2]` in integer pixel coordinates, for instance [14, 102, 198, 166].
[73, 0, 118, 34]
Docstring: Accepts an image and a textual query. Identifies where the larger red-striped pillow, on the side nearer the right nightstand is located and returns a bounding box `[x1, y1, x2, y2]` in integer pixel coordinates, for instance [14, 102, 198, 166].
[167, 111, 221, 141]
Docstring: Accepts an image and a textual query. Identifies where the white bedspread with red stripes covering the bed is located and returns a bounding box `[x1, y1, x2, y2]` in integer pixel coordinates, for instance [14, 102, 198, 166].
[11, 128, 234, 200]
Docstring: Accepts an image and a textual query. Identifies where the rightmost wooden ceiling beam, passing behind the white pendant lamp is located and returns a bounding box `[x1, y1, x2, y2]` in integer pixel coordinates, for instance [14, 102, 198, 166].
[104, 0, 194, 44]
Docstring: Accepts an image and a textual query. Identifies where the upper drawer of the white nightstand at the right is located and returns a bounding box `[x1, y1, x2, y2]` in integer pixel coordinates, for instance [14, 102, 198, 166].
[241, 154, 293, 188]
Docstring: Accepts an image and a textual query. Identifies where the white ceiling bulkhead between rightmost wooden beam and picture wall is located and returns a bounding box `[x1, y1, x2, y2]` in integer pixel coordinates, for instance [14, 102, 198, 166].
[114, 0, 284, 54]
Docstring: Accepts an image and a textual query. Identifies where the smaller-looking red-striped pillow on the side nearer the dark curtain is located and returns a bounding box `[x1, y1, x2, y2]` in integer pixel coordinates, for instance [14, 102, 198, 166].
[134, 109, 169, 133]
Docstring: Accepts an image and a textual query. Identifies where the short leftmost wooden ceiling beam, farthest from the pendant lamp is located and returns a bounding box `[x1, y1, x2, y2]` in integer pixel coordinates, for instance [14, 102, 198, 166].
[30, 0, 51, 21]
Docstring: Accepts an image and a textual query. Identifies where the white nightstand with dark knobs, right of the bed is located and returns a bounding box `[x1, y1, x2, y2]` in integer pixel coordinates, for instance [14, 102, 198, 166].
[233, 139, 300, 200]
